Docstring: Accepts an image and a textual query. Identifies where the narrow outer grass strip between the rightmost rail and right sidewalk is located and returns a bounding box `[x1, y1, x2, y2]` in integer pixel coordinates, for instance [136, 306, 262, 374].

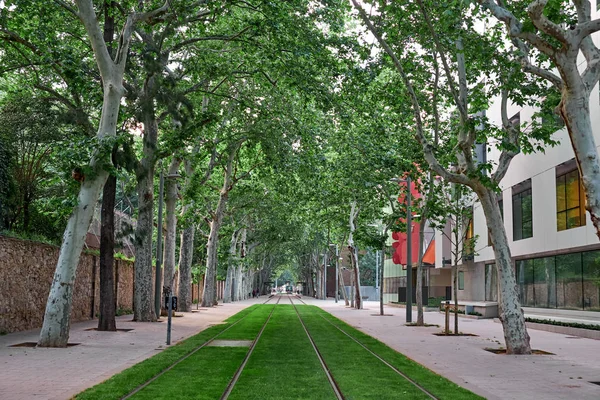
[311, 306, 483, 400]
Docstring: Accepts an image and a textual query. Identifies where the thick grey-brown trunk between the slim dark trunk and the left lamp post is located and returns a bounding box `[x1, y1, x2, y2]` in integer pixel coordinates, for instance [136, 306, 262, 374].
[133, 107, 162, 322]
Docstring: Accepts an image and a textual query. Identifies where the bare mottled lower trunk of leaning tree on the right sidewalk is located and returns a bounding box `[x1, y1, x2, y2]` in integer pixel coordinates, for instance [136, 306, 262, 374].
[476, 185, 531, 354]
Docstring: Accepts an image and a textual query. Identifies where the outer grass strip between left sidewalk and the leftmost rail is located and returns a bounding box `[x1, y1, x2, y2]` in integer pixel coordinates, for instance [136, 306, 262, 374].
[76, 305, 258, 400]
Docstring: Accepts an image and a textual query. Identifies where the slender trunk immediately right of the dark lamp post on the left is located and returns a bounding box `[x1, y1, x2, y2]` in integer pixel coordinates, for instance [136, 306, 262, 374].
[162, 157, 181, 315]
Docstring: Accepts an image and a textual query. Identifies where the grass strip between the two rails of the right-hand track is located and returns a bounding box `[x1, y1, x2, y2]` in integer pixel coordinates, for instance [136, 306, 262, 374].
[298, 306, 430, 400]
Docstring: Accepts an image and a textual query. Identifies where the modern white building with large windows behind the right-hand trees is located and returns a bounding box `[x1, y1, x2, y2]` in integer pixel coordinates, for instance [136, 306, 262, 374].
[435, 90, 600, 311]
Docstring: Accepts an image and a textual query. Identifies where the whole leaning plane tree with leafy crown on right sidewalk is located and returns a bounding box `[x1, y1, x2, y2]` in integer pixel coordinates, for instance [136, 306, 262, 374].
[353, 0, 564, 354]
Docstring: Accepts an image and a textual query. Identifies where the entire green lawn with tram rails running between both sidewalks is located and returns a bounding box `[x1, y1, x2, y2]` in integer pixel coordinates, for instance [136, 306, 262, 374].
[77, 304, 481, 400]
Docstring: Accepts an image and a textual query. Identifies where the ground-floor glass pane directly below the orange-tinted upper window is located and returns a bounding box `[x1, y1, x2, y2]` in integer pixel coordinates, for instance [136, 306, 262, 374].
[556, 253, 583, 310]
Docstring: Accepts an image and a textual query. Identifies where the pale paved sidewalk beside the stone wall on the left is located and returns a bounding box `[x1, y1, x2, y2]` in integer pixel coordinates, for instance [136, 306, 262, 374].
[0, 296, 267, 400]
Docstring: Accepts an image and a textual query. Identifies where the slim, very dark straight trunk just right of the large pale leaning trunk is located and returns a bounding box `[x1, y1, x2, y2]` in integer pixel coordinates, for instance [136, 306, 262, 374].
[98, 175, 117, 331]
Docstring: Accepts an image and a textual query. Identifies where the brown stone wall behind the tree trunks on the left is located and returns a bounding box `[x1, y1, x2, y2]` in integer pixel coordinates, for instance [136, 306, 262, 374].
[0, 236, 134, 333]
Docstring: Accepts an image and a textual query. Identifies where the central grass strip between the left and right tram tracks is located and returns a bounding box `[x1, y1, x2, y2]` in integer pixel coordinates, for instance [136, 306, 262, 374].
[229, 305, 335, 400]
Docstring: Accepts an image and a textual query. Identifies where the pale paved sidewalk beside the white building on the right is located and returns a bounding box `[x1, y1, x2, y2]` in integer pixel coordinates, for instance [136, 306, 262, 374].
[303, 298, 600, 400]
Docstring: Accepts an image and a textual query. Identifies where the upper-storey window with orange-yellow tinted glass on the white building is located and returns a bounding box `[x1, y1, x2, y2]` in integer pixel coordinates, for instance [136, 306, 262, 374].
[556, 170, 585, 231]
